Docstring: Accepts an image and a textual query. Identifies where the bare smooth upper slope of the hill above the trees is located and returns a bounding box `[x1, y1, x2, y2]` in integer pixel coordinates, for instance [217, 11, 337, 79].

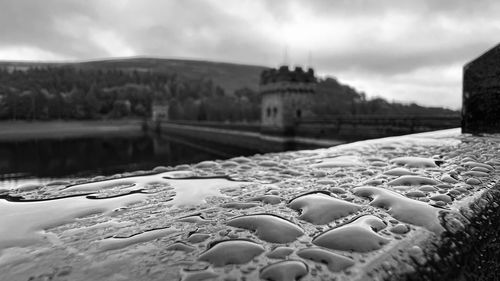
[0, 57, 266, 94]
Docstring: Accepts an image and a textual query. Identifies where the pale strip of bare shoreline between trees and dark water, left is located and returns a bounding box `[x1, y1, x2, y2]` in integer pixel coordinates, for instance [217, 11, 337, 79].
[0, 119, 143, 141]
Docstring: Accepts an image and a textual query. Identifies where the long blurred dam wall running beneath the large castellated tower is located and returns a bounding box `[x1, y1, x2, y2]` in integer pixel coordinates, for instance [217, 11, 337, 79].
[148, 116, 460, 152]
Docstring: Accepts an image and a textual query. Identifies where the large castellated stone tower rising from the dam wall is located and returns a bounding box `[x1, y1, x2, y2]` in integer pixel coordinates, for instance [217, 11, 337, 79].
[260, 66, 316, 135]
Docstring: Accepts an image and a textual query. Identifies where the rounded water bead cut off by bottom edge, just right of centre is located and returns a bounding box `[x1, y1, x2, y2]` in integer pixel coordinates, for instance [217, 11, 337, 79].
[260, 260, 308, 281]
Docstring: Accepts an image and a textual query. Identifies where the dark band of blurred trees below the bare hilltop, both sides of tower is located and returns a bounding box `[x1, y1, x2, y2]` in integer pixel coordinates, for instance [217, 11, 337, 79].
[0, 66, 457, 122]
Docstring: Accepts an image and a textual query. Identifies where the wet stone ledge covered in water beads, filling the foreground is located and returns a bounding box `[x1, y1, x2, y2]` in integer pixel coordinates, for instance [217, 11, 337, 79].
[0, 130, 500, 280]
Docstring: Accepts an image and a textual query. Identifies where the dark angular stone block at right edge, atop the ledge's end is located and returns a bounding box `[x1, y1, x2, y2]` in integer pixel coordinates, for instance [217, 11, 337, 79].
[462, 44, 500, 133]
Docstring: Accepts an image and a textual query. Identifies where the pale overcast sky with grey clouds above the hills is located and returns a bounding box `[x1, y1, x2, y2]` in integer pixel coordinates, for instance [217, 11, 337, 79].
[0, 0, 500, 109]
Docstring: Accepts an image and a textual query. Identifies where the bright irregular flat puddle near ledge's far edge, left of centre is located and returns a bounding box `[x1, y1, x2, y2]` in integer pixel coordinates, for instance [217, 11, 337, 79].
[64, 171, 250, 207]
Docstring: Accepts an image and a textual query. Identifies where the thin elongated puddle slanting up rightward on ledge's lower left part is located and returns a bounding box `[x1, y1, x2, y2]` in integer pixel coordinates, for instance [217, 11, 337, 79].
[97, 228, 179, 251]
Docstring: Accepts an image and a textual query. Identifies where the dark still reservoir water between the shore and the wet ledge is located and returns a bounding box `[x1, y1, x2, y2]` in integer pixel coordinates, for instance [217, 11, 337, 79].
[0, 134, 257, 188]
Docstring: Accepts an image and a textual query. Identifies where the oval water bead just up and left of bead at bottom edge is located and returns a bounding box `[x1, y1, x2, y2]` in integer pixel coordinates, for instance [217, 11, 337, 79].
[198, 239, 264, 266]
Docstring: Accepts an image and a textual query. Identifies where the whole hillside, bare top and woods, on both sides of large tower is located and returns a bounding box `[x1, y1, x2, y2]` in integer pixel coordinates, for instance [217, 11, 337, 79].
[0, 57, 459, 121]
